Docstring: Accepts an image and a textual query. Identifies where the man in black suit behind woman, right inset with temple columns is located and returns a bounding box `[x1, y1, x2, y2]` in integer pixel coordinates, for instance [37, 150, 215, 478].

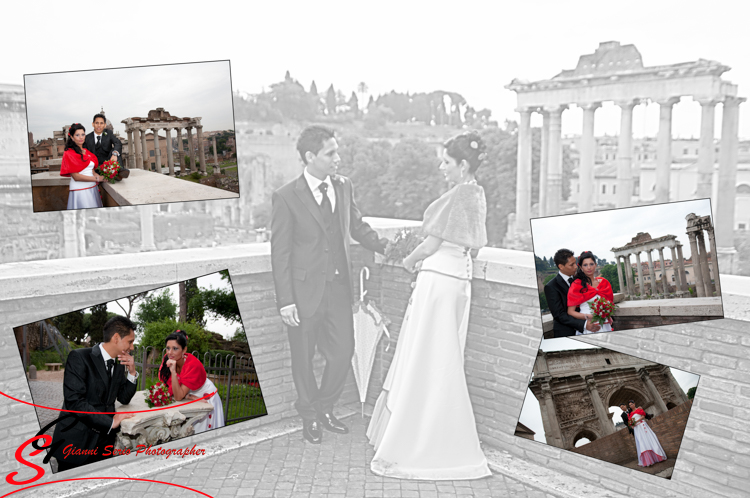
[544, 249, 601, 337]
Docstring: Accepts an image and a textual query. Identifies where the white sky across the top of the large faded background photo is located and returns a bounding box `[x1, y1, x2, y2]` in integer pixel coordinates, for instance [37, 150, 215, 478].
[0, 0, 750, 139]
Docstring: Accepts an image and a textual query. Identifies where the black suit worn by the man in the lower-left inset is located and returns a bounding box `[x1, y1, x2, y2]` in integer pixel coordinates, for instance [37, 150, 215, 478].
[52, 344, 136, 466]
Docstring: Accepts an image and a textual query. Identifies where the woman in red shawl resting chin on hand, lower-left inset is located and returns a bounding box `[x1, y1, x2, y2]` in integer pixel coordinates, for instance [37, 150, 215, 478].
[159, 330, 224, 434]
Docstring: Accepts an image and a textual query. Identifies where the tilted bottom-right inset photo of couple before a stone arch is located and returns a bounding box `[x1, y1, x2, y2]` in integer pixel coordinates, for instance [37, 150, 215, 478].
[515, 338, 700, 479]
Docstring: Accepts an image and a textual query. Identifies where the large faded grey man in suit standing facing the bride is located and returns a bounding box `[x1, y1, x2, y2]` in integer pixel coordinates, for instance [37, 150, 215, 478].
[271, 126, 387, 444]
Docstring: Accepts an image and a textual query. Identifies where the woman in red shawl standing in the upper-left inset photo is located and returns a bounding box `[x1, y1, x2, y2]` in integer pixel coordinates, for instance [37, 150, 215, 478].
[60, 123, 104, 209]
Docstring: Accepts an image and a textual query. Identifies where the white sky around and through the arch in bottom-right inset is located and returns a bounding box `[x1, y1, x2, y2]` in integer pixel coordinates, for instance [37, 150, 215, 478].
[518, 337, 700, 446]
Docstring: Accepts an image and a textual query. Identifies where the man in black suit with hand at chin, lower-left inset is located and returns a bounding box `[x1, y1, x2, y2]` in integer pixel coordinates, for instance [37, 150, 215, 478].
[52, 316, 138, 471]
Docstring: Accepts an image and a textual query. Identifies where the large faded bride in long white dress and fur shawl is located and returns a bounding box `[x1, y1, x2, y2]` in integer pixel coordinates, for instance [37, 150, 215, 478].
[367, 132, 491, 480]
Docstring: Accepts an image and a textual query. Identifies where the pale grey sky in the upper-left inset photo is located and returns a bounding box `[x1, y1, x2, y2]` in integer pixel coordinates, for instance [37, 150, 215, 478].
[24, 61, 234, 140]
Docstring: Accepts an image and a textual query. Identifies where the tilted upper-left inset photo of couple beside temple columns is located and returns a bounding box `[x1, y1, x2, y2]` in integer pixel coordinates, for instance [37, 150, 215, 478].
[24, 60, 240, 213]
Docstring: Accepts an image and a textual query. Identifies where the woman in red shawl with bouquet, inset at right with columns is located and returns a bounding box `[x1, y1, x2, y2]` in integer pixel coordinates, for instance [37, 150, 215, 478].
[568, 251, 615, 335]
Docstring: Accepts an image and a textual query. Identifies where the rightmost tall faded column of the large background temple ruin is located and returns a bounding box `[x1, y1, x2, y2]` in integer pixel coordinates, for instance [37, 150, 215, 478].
[714, 97, 746, 274]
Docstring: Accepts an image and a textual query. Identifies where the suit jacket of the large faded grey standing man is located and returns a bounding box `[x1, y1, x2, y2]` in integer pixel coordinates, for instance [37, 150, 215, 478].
[271, 173, 387, 317]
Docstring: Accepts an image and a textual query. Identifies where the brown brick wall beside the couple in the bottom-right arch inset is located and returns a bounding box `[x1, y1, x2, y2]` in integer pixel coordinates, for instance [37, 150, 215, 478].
[571, 401, 693, 464]
